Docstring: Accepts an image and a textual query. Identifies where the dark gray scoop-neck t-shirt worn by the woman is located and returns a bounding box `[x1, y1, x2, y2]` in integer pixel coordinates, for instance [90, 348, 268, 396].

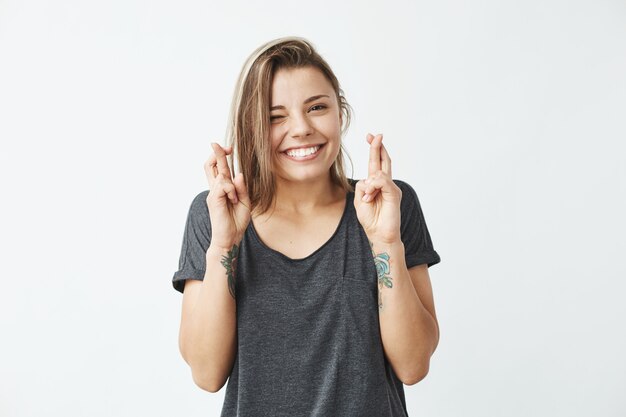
[172, 179, 440, 417]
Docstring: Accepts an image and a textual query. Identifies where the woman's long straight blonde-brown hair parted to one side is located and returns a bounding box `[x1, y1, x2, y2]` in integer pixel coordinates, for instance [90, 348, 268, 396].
[227, 36, 354, 213]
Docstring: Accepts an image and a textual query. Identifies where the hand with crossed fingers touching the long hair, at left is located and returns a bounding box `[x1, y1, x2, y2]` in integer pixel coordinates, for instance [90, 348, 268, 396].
[204, 143, 251, 250]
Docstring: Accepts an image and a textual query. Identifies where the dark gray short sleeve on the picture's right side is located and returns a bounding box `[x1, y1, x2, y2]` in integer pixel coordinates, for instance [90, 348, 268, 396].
[393, 180, 441, 268]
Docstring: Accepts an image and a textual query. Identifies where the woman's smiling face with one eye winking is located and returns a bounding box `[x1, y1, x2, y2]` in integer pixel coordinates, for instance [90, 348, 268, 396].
[270, 67, 341, 185]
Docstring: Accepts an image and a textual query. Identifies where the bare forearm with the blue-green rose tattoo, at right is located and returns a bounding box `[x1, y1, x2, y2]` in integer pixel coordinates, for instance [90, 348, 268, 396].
[371, 241, 439, 384]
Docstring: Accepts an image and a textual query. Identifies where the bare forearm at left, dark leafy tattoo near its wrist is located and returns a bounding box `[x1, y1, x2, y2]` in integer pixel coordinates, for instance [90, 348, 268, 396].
[181, 242, 237, 391]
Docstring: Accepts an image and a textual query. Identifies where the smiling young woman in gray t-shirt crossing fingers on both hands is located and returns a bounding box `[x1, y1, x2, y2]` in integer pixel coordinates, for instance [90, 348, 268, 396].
[173, 37, 440, 417]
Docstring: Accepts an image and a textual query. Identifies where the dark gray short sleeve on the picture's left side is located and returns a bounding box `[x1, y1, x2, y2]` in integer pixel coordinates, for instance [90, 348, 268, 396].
[172, 190, 211, 293]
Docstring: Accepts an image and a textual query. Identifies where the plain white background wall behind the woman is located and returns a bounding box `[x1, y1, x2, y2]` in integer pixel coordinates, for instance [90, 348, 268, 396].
[0, 0, 626, 417]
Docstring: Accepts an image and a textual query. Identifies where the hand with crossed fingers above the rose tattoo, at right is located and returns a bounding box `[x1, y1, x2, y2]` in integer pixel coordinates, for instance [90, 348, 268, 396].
[354, 133, 402, 243]
